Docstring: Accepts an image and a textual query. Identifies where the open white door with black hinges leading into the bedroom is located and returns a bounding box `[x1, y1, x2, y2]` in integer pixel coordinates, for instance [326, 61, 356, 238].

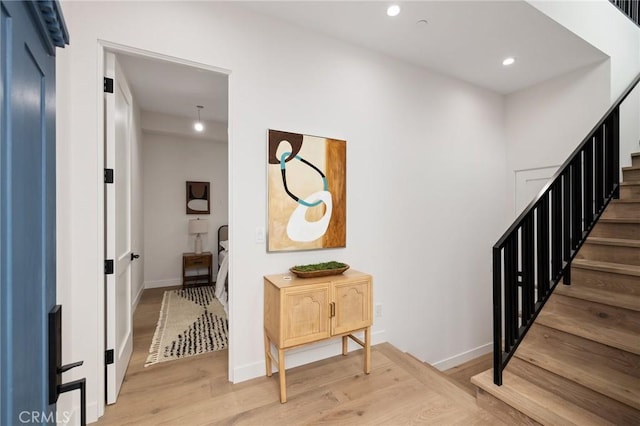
[105, 53, 133, 404]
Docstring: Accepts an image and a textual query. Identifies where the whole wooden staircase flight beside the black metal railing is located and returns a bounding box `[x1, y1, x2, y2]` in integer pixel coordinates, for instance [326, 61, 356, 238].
[471, 153, 640, 425]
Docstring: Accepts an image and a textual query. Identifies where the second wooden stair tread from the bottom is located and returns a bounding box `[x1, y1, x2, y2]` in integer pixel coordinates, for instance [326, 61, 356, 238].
[515, 325, 640, 410]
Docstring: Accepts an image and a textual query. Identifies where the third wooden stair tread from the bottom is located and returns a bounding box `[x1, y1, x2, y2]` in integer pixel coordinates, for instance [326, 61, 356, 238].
[536, 294, 640, 355]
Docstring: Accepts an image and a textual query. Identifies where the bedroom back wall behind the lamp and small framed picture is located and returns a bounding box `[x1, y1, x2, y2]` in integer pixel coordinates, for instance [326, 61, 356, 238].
[144, 120, 228, 288]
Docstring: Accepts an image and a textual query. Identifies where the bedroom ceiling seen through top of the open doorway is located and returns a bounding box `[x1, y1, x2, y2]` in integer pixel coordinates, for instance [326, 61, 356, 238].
[118, 54, 229, 122]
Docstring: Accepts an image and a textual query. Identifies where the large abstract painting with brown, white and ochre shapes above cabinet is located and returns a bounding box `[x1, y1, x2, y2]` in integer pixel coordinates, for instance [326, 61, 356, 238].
[267, 130, 347, 252]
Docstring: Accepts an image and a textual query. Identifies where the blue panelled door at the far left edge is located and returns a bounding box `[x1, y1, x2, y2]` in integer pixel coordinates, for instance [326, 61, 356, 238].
[0, 1, 68, 425]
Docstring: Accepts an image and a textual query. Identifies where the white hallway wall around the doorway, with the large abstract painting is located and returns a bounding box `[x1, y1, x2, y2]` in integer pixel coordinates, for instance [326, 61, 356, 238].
[58, 2, 506, 421]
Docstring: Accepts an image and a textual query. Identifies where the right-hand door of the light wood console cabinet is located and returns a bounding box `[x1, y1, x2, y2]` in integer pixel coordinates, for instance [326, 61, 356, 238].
[331, 280, 372, 335]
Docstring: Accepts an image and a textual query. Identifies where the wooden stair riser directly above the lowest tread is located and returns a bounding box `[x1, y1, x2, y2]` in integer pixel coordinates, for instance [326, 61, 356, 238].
[507, 357, 639, 425]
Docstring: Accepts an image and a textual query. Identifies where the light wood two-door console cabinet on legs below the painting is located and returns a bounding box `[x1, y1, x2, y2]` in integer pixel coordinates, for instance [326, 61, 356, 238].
[264, 270, 373, 403]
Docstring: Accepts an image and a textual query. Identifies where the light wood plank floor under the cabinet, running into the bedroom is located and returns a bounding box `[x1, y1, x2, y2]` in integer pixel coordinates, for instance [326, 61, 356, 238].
[97, 289, 501, 425]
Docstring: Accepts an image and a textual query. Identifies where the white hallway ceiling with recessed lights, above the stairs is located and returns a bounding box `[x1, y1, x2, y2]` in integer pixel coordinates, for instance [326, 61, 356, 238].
[238, 0, 607, 94]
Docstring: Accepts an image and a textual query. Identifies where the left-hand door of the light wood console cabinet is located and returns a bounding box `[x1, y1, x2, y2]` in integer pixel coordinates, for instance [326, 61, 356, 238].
[282, 283, 330, 348]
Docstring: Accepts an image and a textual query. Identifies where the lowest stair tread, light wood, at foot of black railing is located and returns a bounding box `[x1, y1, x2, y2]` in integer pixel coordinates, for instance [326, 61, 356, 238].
[471, 370, 612, 425]
